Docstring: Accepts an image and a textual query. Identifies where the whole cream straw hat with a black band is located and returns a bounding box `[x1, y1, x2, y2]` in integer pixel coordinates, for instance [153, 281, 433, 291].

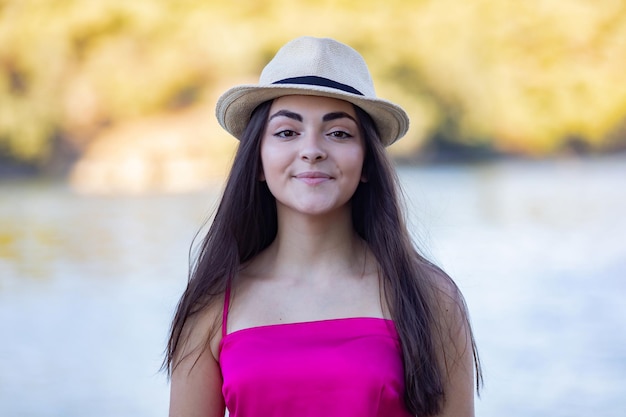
[215, 36, 409, 146]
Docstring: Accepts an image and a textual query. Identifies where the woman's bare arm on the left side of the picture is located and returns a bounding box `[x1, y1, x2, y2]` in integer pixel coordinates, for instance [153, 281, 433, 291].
[169, 309, 225, 417]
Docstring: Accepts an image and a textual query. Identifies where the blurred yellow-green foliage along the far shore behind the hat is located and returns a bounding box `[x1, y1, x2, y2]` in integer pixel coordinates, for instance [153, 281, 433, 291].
[0, 0, 626, 161]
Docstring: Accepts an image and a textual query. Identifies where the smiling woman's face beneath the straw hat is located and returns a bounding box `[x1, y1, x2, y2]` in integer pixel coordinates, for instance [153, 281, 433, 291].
[261, 96, 365, 215]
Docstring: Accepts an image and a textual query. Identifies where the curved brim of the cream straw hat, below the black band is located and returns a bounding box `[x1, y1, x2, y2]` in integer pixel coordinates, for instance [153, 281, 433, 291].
[215, 84, 409, 146]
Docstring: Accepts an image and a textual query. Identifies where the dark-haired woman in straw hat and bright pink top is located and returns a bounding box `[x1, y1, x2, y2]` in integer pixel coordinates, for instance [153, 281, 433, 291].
[165, 37, 480, 417]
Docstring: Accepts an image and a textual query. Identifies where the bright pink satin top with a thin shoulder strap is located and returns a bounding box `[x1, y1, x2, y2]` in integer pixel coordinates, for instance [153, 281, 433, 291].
[219, 291, 410, 417]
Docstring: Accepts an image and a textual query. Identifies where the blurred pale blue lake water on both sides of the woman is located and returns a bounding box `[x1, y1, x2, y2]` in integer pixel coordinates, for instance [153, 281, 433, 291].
[0, 156, 626, 417]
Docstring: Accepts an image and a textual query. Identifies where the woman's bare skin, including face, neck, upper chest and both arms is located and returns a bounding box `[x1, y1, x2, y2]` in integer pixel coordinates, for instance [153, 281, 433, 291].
[170, 96, 473, 417]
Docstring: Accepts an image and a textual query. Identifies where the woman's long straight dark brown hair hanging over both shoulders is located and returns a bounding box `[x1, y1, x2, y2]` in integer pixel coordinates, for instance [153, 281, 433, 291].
[164, 101, 481, 416]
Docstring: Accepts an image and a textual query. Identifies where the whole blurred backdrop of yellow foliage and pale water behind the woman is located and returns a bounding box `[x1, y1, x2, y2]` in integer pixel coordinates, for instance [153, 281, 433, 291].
[0, 0, 626, 417]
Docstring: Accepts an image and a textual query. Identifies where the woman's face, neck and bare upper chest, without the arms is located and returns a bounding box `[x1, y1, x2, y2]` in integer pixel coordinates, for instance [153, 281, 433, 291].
[228, 96, 385, 332]
